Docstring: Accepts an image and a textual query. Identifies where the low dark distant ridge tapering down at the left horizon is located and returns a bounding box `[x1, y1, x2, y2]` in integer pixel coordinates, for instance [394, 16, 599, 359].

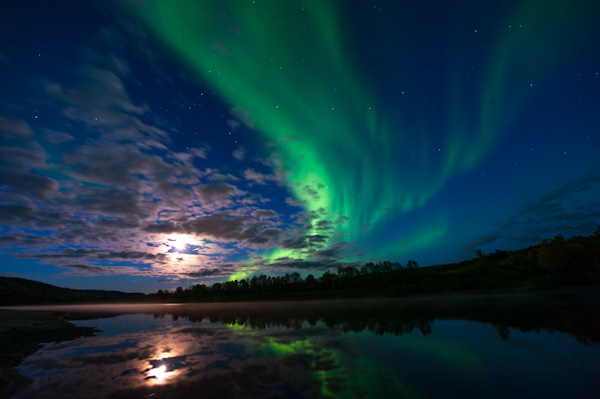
[0, 277, 145, 306]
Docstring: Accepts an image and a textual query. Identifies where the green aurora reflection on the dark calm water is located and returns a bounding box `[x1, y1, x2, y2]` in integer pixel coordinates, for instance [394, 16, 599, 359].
[227, 323, 486, 398]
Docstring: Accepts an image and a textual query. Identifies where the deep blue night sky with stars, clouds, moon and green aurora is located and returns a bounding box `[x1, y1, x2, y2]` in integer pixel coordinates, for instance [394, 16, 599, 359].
[0, 0, 600, 292]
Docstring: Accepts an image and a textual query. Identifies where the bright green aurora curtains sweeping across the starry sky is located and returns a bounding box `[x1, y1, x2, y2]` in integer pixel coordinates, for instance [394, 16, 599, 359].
[130, 0, 593, 268]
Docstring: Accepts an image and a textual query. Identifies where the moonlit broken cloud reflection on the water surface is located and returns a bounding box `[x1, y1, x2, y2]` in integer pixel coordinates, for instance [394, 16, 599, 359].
[17, 325, 360, 398]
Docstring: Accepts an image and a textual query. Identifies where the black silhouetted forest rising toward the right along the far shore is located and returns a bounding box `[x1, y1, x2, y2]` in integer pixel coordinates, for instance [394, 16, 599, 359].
[154, 228, 600, 302]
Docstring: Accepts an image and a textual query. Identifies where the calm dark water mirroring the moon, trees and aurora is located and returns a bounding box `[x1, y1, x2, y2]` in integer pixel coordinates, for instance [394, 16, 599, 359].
[8, 292, 600, 398]
